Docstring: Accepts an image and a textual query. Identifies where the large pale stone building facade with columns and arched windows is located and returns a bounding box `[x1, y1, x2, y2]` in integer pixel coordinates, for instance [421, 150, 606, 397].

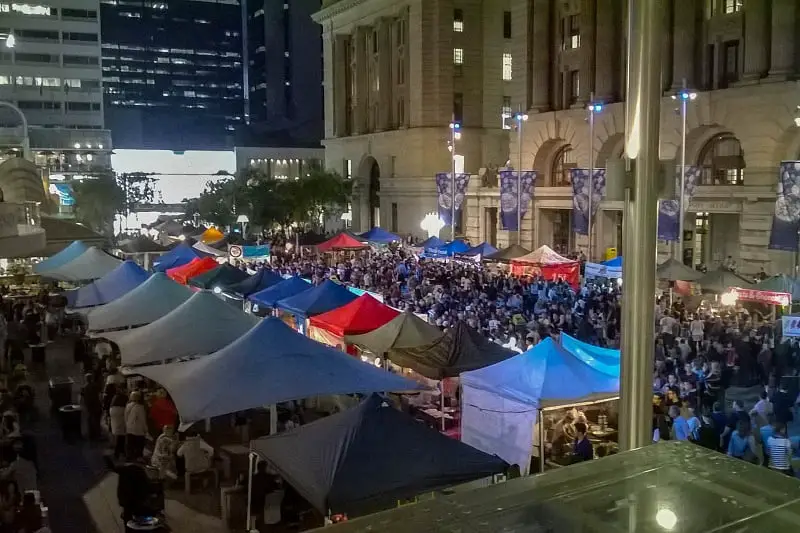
[315, 0, 800, 273]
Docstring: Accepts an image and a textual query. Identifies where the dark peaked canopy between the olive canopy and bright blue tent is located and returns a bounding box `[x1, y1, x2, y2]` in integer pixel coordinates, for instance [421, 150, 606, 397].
[388, 322, 514, 379]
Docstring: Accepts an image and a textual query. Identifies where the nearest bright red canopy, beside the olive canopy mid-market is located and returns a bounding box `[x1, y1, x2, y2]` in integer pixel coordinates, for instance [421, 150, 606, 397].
[308, 294, 400, 355]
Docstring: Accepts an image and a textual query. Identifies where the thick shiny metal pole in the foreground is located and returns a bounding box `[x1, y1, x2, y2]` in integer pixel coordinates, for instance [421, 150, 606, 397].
[619, 0, 663, 450]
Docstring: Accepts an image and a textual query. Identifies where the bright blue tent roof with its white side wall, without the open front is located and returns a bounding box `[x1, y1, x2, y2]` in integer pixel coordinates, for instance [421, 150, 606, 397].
[461, 338, 619, 473]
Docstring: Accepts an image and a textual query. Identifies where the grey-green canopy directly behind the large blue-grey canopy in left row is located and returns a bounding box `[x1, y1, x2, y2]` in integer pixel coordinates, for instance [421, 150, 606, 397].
[109, 291, 258, 366]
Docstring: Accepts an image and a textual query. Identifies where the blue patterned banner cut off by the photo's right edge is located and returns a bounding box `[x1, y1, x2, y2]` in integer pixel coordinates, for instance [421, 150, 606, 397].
[769, 161, 800, 252]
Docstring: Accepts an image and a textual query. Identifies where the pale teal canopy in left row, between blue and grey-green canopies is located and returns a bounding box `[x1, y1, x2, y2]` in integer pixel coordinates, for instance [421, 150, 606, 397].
[86, 272, 192, 333]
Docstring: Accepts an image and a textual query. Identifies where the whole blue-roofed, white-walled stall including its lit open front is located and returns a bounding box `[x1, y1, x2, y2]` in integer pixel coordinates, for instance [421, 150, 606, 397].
[461, 338, 619, 474]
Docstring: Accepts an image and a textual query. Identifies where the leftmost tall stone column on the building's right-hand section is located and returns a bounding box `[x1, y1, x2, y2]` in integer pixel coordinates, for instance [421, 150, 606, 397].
[529, 0, 554, 111]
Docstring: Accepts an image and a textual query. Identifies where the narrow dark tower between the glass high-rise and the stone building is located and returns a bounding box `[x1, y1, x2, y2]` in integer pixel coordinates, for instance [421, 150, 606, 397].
[241, 0, 323, 147]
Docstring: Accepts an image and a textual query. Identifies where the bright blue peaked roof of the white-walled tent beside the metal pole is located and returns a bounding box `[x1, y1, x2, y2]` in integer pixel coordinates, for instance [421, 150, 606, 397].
[461, 337, 619, 408]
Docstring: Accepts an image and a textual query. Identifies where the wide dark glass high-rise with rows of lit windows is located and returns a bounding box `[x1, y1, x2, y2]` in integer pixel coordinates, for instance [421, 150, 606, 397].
[100, 0, 244, 150]
